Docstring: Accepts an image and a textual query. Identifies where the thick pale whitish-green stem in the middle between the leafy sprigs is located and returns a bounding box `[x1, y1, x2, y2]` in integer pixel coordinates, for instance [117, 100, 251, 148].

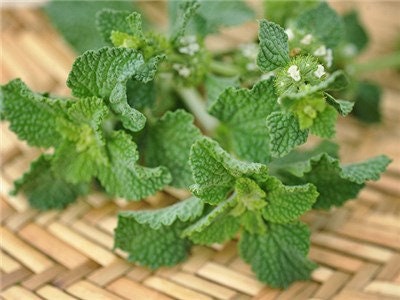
[175, 87, 218, 133]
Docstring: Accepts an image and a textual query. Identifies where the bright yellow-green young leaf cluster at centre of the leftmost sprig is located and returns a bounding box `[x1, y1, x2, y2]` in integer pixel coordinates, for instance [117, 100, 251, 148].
[52, 97, 109, 183]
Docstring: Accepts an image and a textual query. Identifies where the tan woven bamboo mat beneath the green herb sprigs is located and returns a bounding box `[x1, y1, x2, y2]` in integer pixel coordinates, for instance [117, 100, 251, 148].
[0, 4, 400, 300]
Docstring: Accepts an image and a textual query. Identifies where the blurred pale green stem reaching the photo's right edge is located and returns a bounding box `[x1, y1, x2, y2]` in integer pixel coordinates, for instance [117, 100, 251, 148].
[348, 51, 400, 74]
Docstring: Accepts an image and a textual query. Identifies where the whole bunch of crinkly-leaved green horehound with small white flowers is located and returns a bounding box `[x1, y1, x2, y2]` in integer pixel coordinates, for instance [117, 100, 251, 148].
[0, 2, 390, 287]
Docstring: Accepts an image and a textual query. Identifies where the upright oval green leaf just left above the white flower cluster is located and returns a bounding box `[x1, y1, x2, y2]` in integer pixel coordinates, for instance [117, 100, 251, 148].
[257, 20, 290, 72]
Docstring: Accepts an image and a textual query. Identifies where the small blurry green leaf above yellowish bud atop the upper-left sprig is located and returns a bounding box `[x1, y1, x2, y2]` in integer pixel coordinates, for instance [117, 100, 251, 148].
[96, 9, 131, 45]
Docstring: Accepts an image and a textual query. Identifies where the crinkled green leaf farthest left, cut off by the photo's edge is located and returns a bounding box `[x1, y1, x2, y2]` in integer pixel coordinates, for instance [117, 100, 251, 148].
[1, 79, 70, 148]
